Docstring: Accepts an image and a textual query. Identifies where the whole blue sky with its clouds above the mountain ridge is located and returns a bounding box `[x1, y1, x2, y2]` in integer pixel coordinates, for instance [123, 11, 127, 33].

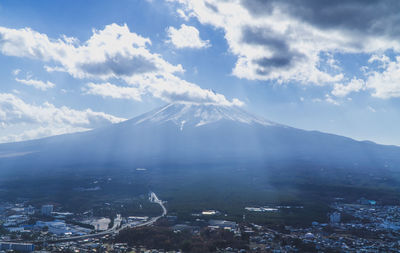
[0, 0, 400, 145]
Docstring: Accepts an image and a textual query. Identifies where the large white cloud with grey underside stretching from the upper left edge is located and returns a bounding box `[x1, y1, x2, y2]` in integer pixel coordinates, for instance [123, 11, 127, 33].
[0, 24, 183, 79]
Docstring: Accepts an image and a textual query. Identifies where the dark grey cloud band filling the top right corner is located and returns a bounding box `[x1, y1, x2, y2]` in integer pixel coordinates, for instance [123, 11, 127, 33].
[242, 0, 400, 38]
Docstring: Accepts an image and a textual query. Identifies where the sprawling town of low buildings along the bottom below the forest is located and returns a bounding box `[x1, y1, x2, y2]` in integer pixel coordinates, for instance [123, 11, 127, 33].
[0, 192, 400, 253]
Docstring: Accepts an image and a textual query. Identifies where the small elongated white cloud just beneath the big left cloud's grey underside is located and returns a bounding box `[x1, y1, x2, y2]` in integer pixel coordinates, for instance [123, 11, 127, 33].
[83, 83, 142, 101]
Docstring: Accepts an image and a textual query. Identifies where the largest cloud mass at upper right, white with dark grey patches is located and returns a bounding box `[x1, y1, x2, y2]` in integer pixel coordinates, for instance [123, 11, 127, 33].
[167, 0, 400, 85]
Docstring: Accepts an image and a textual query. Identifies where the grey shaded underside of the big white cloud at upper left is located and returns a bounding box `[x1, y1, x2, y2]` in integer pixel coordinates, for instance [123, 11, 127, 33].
[79, 54, 157, 76]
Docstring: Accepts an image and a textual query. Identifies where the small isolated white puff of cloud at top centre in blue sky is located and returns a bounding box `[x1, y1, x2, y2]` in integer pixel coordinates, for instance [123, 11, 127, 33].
[167, 24, 211, 48]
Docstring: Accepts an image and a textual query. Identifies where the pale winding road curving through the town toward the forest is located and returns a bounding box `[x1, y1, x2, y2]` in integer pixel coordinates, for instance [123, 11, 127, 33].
[36, 192, 167, 243]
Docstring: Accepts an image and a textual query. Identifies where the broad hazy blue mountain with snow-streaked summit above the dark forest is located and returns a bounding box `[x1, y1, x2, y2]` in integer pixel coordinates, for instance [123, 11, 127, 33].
[0, 103, 400, 170]
